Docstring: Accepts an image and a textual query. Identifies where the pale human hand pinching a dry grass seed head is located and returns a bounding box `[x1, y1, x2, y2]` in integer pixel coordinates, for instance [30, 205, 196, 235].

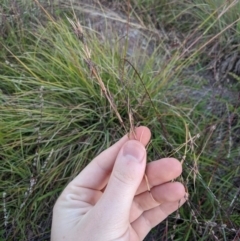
[51, 126, 185, 241]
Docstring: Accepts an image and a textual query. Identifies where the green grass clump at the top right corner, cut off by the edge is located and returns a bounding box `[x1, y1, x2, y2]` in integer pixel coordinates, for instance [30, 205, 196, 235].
[132, 0, 239, 36]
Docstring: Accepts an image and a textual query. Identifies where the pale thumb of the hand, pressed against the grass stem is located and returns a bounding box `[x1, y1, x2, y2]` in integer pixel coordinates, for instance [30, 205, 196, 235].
[98, 140, 146, 223]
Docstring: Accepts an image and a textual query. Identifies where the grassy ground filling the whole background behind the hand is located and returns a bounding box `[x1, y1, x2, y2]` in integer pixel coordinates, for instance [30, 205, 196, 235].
[0, 0, 240, 241]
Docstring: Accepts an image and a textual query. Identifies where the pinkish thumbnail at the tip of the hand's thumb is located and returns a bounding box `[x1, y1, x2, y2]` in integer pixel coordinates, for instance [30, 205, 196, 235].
[123, 141, 146, 162]
